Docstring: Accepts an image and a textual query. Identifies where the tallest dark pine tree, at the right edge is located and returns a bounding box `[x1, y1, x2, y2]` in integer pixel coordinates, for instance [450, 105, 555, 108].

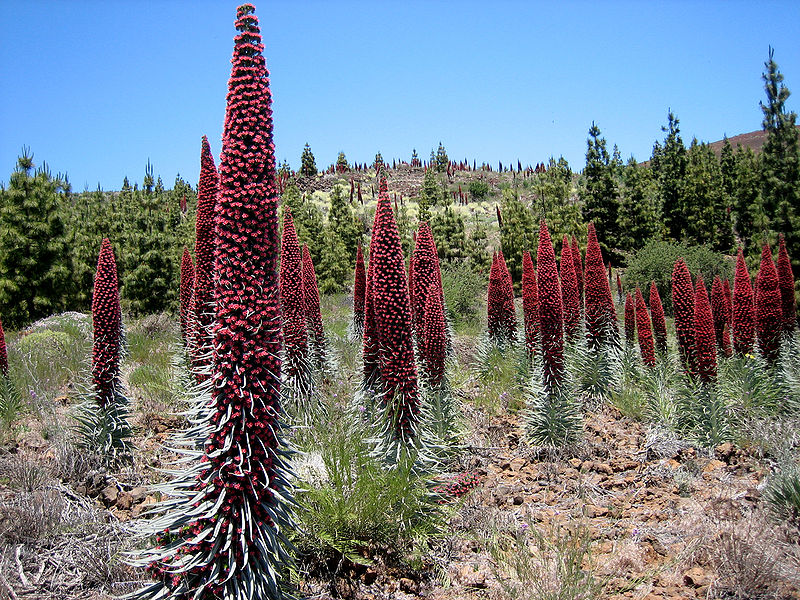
[759, 47, 800, 277]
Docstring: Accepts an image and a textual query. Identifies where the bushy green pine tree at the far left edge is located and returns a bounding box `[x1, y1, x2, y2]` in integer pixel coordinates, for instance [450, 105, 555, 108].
[0, 149, 72, 328]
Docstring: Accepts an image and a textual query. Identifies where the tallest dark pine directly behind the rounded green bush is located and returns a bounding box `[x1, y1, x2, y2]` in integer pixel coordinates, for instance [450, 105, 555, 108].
[650, 111, 687, 241]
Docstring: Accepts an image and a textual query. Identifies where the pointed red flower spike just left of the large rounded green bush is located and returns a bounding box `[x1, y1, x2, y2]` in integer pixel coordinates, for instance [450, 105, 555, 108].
[584, 223, 619, 349]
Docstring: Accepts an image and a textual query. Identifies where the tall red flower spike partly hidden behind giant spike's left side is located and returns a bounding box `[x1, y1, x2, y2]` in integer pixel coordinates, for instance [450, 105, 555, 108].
[189, 136, 219, 382]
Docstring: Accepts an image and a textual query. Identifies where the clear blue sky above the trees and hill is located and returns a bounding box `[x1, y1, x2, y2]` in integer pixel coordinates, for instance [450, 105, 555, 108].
[0, 0, 800, 191]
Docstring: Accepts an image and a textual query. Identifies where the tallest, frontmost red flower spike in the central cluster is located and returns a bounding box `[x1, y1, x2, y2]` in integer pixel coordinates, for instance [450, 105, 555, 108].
[369, 177, 419, 441]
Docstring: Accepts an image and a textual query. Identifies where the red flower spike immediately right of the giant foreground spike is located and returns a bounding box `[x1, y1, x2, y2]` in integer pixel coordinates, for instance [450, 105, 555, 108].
[280, 205, 312, 401]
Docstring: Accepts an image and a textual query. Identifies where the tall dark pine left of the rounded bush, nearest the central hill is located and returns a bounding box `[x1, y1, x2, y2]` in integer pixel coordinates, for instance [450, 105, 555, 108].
[580, 123, 620, 263]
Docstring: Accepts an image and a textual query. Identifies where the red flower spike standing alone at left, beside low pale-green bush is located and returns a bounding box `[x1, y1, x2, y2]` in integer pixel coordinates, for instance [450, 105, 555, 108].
[92, 238, 122, 407]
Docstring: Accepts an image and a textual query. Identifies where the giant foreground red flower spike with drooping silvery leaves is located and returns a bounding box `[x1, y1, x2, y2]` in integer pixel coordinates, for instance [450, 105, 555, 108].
[135, 4, 293, 600]
